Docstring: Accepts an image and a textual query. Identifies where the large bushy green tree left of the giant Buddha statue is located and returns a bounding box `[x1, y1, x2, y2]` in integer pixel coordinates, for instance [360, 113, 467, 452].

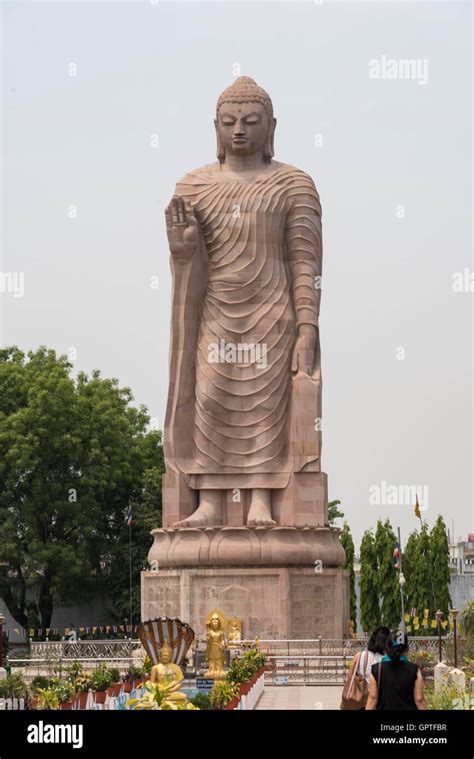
[0, 347, 162, 627]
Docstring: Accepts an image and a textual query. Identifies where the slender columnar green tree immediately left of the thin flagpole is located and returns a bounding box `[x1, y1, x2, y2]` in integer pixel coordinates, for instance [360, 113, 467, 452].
[374, 519, 401, 628]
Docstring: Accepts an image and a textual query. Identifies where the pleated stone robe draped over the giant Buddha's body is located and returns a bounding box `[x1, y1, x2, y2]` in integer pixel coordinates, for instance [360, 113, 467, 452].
[165, 162, 322, 488]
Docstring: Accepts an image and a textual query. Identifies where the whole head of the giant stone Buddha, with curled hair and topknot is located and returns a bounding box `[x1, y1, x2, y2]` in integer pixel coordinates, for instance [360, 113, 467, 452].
[214, 76, 276, 163]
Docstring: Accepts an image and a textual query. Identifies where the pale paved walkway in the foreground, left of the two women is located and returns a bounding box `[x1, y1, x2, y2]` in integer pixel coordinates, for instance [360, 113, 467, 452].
[256, 685, 342, 710]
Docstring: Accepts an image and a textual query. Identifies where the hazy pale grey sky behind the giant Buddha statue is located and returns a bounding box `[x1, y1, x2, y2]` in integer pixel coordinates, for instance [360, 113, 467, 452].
[0, 0, 474, 550]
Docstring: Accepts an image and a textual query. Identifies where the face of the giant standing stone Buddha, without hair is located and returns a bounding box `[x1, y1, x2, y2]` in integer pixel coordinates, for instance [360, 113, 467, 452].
[216, 102, 270, 156]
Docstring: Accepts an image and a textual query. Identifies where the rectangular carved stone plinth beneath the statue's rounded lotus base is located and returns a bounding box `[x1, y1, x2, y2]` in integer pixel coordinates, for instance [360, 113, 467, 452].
[141, 566, 349, 639]
